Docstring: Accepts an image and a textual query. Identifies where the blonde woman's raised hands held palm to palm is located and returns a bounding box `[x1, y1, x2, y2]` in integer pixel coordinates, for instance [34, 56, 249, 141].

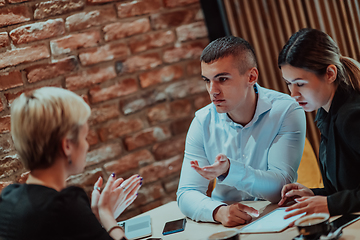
[91, 175, 142, 219]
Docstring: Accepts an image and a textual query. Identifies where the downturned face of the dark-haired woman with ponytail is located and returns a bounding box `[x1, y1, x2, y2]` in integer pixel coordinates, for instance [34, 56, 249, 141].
[281, 64, 336, 112]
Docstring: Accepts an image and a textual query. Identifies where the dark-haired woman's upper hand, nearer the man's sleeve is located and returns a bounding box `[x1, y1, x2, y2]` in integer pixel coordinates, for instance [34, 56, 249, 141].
[278, 183, 314, 207]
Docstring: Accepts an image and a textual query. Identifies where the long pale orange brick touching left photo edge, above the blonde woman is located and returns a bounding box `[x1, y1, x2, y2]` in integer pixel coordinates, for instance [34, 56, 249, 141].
[0, 45, 50, 68]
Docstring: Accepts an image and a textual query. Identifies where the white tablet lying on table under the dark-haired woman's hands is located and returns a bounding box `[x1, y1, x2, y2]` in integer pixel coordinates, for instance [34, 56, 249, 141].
[240, 207, 306, 233]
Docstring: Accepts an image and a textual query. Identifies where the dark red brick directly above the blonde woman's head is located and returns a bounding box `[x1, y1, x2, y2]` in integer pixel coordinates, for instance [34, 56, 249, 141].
[25, 57, 78, 83]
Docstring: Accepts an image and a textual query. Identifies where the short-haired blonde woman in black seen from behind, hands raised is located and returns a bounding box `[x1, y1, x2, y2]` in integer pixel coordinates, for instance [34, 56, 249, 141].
[0, 87, 142, 240]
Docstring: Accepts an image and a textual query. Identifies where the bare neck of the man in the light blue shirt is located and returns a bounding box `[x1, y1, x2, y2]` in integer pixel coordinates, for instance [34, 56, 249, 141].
[228, 88, 258, 126]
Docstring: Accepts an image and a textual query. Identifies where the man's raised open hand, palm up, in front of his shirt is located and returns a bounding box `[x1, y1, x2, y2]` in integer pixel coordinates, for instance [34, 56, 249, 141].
[190, 154, 230, 180]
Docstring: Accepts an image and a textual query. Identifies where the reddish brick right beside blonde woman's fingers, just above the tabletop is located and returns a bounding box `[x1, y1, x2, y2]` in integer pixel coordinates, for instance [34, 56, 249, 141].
[134, 183, 166, 207]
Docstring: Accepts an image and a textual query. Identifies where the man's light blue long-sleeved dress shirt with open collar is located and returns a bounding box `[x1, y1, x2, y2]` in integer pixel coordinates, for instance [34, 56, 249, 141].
[177, 84, 306, 222]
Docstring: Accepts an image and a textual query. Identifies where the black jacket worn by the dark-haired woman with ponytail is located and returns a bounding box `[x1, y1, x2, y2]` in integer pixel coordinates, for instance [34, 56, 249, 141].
[312, 87, 360, 216]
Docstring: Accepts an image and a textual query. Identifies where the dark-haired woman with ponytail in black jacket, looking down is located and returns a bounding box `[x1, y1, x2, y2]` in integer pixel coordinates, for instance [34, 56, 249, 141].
[278, 29, 360, 218]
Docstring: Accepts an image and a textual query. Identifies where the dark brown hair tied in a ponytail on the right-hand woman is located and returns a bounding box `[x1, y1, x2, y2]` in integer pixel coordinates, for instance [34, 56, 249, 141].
[278, 28, 360, 92]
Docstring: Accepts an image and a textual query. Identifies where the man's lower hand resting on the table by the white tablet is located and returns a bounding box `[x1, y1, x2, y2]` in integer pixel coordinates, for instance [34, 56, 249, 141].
[213, 203, 259, 227]
